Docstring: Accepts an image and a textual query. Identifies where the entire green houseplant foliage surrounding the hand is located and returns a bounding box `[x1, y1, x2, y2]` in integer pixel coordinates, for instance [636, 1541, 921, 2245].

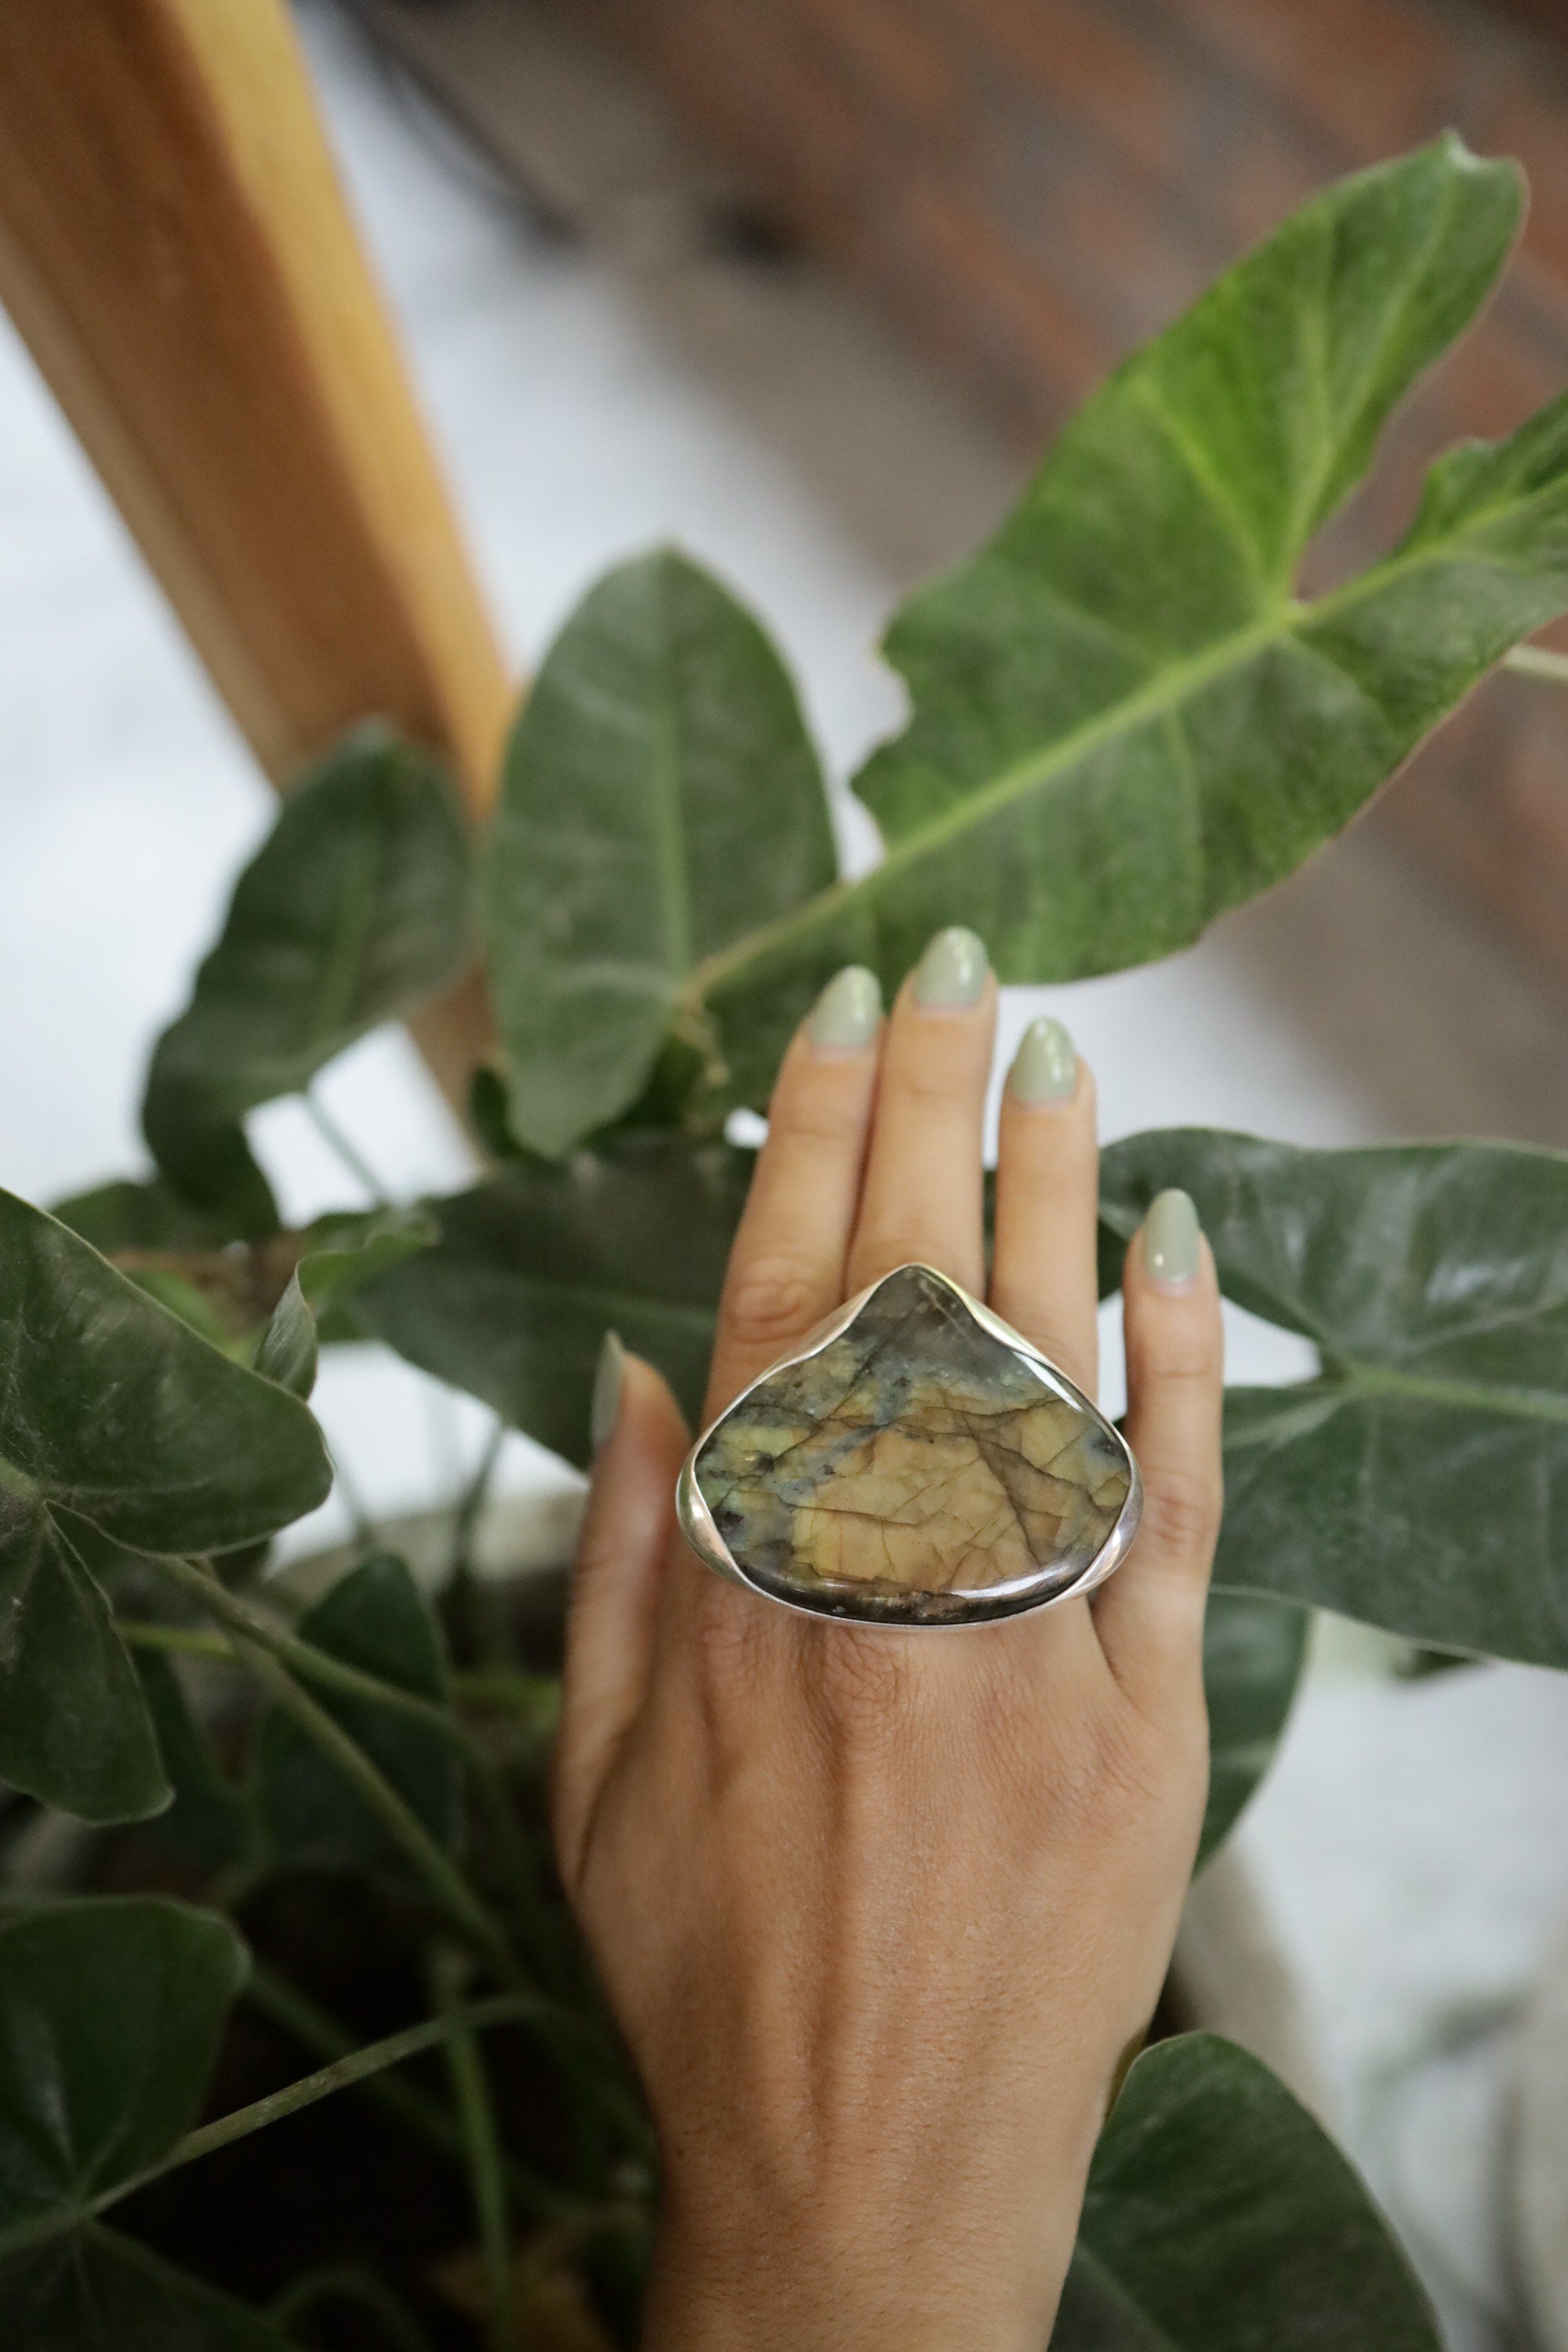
[0, 139, 1568, 2352]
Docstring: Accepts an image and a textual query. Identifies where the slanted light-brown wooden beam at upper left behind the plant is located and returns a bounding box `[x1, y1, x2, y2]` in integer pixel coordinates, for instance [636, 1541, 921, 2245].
[0, 0, 513, 1101]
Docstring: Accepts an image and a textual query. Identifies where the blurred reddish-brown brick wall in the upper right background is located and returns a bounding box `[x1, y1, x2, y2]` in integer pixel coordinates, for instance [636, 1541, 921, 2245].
[562, 0, 1568, 978]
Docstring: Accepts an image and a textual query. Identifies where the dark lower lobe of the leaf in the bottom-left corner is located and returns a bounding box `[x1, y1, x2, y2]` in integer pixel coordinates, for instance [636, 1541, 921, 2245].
[0, 2227, 289, 2352]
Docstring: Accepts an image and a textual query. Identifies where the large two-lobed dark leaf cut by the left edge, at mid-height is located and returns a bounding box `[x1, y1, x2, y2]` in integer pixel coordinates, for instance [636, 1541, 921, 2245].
[0, 1192, 332, 1820]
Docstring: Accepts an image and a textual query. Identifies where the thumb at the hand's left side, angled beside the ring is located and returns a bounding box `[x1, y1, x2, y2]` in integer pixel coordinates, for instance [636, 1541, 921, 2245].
[553, 1331, 687, 1886]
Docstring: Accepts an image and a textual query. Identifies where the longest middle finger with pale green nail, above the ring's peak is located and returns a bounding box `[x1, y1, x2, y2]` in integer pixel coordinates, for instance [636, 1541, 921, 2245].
[844, 929, 996, 1291]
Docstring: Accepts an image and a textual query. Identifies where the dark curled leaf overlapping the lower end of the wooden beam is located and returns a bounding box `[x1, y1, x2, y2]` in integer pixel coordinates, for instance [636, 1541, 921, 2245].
[141, 724, 473, 1237]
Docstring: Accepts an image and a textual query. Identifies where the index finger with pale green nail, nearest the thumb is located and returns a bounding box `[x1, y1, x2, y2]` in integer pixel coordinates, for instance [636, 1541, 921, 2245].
[706, 964, 881, 1418]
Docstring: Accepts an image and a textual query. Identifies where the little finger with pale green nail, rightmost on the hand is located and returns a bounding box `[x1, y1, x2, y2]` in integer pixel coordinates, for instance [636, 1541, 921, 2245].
[1093, 1192, 1225, 1686]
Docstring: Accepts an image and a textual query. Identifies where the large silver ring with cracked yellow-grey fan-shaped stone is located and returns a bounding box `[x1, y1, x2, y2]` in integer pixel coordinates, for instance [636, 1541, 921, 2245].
[677, 1265, 1142, 1625]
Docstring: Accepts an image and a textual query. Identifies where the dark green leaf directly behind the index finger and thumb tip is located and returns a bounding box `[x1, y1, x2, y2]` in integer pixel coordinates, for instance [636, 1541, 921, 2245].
[362, 1134, 753, 1463]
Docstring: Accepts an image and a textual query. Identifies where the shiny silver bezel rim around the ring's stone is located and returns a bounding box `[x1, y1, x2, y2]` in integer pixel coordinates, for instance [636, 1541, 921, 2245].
[675, 1258, 1142, 1632]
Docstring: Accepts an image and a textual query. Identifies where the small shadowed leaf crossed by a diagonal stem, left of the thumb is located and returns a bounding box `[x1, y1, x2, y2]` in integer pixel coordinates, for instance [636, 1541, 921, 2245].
[254, 1552, 461, 1877]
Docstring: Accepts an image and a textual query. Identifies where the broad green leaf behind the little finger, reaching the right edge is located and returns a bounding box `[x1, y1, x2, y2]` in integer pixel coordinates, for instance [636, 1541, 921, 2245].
[1100, 1129, 1568, 1665]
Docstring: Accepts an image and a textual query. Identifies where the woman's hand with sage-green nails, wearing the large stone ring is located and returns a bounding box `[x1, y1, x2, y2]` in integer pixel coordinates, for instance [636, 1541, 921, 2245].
[555, 931, 1220, 2352]
